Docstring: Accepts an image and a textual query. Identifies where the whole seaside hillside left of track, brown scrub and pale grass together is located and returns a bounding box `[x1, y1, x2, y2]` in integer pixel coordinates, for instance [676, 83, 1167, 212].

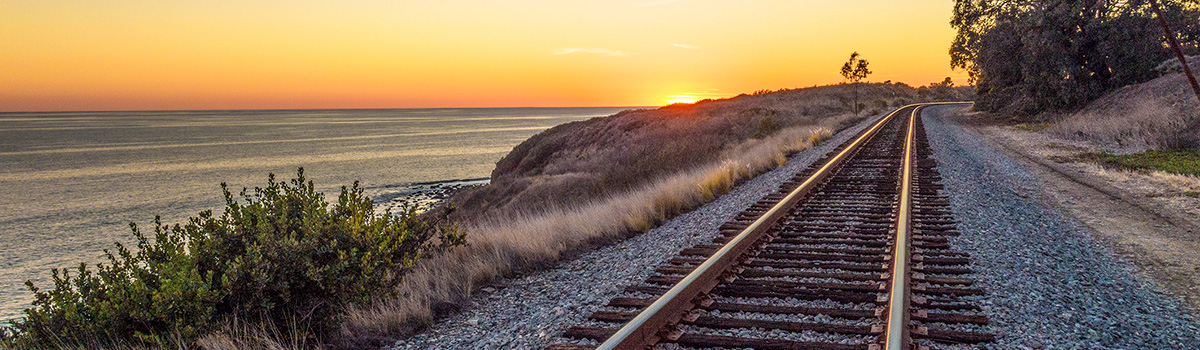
[336, 84, 970, 334]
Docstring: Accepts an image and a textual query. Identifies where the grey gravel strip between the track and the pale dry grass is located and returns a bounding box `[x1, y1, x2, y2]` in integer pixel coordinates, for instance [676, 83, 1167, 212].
[391, 116, 878, 350]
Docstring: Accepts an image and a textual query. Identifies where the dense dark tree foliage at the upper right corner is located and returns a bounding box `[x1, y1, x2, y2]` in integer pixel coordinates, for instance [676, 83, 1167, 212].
[950, 0, 1200, 114]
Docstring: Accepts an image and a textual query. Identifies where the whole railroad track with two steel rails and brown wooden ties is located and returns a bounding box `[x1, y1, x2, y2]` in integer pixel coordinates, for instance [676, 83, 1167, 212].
[550, 104, 994, 350]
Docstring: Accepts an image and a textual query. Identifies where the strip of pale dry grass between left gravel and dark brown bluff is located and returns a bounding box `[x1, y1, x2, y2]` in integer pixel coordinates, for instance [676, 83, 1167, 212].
[333, 127, 832, 342]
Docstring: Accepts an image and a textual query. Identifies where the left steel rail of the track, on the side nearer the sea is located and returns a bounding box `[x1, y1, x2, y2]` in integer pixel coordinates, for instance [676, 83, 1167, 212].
[596, 104, 919, 350]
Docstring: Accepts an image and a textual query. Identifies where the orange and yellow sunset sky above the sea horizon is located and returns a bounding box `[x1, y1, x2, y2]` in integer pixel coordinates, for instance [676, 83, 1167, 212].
[0, 0, 966, 111]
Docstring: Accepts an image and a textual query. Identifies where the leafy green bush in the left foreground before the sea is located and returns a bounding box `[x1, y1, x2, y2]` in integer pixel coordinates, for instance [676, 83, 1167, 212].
[0, 169, 464, 348]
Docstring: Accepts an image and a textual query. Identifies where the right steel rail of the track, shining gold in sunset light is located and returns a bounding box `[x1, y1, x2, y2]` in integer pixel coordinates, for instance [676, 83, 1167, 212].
[883, 105, 924, 350]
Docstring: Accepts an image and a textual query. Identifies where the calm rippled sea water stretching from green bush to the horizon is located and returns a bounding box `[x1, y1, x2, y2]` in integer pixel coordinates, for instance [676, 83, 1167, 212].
[0, 108, 624, 321]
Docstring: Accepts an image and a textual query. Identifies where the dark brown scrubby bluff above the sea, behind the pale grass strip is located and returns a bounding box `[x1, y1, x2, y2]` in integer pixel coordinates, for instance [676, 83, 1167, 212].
[451, 84, 965, 219]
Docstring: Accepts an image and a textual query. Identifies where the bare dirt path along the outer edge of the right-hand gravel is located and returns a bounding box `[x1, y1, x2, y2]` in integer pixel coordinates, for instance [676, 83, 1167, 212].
[964, 112, 1200, 319]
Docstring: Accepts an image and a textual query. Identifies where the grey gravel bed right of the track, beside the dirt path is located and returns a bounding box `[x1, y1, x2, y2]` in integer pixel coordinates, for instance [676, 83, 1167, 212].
[925, 107, 1200, 349]
